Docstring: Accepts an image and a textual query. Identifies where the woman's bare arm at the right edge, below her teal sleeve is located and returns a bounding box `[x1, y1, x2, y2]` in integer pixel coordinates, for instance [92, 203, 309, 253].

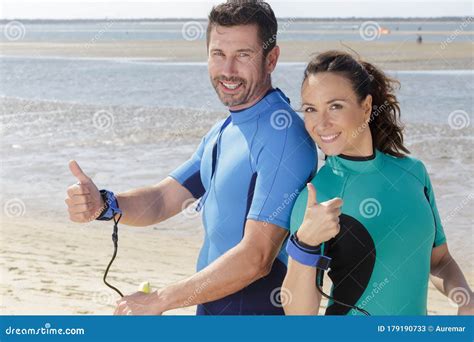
[431, 243, 474, 315]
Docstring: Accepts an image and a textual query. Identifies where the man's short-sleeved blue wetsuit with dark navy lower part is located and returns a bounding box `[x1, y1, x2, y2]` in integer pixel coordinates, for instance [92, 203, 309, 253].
[170, 89, 317, 315]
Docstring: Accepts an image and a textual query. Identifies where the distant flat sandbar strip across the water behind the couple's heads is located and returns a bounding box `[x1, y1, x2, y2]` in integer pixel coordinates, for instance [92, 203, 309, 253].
[0, 41, 474, 70]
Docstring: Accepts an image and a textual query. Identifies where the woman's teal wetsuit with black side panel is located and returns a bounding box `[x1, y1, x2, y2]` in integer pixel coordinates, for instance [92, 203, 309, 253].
[291, 150, 446, 315]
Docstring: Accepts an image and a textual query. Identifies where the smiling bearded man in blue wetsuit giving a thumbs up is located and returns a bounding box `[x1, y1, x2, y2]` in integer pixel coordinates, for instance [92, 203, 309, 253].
[66, 1, 316, 315]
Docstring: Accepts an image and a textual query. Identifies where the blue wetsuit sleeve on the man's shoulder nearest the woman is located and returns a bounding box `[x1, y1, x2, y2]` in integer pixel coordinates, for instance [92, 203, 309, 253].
[247, 118, 317, 229]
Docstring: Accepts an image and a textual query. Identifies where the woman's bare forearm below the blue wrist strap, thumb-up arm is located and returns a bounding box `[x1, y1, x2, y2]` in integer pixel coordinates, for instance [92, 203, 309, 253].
[282, 257, 321, 315]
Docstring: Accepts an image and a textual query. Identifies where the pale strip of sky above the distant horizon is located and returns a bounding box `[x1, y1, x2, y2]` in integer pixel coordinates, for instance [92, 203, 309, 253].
[0, 0, 474, 19]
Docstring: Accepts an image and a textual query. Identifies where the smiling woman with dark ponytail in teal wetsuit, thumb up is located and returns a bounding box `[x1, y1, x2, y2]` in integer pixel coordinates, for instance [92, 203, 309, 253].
[283, 51, 474, 315]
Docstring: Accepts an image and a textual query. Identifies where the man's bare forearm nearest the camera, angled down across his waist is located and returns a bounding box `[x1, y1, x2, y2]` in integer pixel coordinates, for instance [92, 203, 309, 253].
[157, 246, 273, 311]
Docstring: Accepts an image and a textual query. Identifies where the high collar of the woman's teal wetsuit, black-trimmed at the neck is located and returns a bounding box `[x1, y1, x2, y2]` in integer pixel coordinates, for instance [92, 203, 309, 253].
[326, 149, 384, 173]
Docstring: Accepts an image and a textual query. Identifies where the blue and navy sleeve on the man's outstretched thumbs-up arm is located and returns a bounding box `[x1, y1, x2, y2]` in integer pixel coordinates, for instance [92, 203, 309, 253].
[169, 137, 206, 199]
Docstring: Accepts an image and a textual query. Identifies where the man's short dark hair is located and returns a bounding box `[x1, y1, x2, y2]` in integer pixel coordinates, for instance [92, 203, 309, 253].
[207, 0, 278, 56]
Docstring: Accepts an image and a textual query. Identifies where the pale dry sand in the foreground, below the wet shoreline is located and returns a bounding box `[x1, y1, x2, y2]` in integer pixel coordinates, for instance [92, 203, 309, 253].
[0, 216, 466, 315]
